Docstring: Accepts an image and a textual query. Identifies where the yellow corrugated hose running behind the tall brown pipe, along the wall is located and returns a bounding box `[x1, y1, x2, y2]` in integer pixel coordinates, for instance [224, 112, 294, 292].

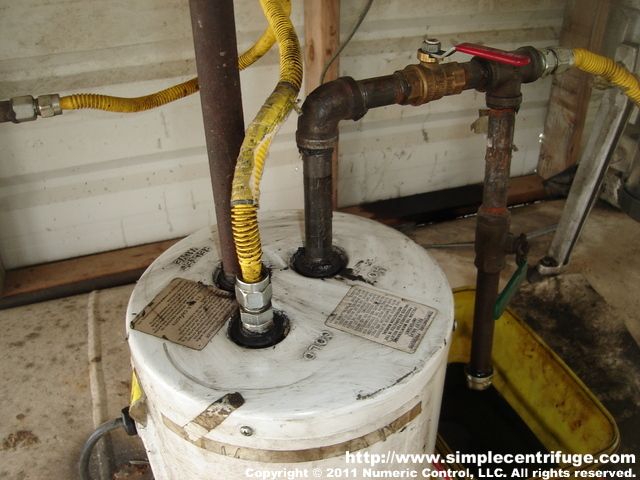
[60, 0, 291, 113]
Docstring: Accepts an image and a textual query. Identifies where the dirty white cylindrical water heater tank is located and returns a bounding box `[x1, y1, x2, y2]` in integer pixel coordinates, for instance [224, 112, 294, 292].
[127, 211, 454, 480]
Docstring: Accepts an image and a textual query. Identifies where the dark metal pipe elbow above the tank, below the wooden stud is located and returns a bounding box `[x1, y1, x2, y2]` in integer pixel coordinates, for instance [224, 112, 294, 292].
[296, 77, 367, 151]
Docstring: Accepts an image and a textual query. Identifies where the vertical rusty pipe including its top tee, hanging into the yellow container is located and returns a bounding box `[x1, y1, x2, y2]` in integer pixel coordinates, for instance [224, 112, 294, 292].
[465, 47, 547, 390]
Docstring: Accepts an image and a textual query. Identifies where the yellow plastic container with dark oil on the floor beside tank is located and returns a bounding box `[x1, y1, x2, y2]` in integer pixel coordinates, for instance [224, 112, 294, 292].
[436, 288, 619, 478]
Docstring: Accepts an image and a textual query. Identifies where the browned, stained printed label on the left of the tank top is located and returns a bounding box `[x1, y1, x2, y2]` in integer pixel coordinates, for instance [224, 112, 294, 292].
[131, 278, 237, 350]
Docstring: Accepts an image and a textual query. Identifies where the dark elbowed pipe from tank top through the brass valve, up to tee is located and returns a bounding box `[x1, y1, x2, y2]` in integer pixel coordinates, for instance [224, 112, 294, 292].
[292, 59, 489, 278]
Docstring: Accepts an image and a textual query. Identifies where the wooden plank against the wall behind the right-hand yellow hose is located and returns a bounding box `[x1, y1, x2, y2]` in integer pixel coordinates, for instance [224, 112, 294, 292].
[538, 0, 611, 179]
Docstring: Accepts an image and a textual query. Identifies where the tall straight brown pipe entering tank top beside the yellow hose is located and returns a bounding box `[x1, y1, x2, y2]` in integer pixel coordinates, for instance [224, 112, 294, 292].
[189, 0, 244, 284]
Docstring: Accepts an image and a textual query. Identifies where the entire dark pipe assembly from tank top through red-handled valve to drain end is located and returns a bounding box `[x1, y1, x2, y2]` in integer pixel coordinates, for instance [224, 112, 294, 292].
[292, 46, 549, 390]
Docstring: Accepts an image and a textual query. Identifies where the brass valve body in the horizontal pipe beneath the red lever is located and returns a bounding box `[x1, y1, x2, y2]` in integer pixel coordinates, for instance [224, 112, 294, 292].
[400, 62, 467, 106]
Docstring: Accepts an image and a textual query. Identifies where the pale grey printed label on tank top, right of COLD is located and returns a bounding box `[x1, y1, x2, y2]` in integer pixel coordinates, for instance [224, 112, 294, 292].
[325, 286, 438, 353]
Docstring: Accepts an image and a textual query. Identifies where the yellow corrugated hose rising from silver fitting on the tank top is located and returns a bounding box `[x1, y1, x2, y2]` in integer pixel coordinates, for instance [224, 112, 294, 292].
[231, 0, 302, 283]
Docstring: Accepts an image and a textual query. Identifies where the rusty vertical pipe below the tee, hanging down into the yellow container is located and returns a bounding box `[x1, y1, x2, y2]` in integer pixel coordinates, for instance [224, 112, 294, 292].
[467, 108, 516, 390]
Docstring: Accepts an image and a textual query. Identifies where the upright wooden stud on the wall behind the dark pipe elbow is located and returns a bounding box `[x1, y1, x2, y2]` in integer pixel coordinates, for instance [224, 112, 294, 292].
[304, 0, 340, 210]
